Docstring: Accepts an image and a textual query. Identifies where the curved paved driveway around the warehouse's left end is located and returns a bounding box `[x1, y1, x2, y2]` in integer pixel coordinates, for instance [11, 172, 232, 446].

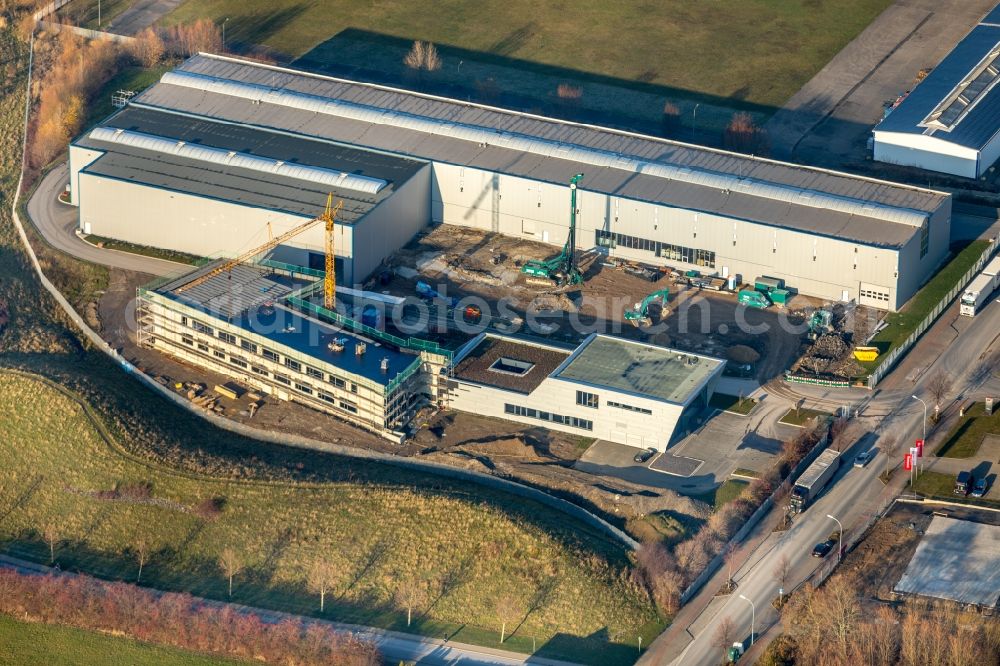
[28, 164, 191, 276]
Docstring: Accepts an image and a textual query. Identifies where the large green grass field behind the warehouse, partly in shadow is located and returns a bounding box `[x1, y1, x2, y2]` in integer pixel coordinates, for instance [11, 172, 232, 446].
[165, 0, 891, 132]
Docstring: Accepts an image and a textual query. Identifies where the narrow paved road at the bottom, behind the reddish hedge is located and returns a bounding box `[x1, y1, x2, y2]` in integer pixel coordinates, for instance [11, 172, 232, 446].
[0, 555, 575, 666]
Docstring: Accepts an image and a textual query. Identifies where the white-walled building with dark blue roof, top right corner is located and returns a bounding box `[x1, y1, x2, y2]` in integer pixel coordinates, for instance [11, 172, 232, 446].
[874, 7, 1000, 178]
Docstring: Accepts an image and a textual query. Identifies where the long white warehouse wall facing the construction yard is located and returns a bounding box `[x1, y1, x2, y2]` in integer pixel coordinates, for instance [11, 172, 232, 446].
[432, 163, 920, 309]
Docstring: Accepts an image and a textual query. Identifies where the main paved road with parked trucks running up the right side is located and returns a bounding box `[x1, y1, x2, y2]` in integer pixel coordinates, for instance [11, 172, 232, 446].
[641, 296, 1000, 666]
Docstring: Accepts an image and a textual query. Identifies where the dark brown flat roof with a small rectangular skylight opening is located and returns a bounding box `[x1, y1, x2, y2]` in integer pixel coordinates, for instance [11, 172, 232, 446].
[453, 334, 571, 395]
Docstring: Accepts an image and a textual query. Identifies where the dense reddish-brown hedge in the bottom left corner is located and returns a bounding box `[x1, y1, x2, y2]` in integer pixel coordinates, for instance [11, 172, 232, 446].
[0, 569, 382, 666]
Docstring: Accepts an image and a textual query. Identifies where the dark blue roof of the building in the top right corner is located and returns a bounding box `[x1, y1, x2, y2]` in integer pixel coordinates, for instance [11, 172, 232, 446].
[875, 13, 1000, 150]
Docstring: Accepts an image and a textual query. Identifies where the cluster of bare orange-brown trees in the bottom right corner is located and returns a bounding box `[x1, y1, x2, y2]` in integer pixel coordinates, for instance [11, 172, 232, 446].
[760, 575, 1000, 666]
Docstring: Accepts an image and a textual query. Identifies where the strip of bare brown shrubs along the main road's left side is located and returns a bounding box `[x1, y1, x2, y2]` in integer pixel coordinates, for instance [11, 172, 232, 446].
[635, 426, 824, 613]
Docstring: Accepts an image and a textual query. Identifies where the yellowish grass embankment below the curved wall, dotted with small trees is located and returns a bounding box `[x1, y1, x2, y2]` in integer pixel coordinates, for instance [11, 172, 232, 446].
[0, 373, 659, 663]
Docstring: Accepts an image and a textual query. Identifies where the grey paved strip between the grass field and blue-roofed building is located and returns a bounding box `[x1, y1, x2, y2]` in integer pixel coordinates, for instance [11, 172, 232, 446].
[766, 0, 996, 166]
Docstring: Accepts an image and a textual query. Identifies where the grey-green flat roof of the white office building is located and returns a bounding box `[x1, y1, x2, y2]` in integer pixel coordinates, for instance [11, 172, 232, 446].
[553, 334, 725, 405]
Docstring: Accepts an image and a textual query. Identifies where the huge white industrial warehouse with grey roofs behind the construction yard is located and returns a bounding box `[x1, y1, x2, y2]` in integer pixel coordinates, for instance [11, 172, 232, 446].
[70, 54, 951, 310]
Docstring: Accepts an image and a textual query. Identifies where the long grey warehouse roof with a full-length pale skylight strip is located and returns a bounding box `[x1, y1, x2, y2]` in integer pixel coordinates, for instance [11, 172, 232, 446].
[131, 54, 948, 247]
